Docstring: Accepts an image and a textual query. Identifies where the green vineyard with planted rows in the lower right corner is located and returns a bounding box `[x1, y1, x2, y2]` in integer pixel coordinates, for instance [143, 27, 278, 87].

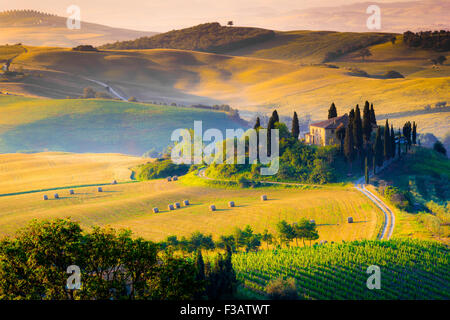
[233, 240, 450, 300]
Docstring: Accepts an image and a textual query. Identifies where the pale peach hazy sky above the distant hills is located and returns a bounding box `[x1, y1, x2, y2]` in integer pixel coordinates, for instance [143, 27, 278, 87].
[0, 0, 420, 32]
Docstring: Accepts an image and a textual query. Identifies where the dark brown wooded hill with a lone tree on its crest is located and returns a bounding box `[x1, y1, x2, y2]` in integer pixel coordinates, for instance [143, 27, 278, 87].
[102, 22, 275, 53]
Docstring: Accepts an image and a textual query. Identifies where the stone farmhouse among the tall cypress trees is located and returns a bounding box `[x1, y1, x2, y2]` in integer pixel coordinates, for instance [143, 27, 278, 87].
[305, 114, 349, 146]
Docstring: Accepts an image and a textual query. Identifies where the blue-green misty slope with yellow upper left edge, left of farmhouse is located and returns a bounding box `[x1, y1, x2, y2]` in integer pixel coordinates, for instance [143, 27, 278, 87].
[0, 96, 241, 155]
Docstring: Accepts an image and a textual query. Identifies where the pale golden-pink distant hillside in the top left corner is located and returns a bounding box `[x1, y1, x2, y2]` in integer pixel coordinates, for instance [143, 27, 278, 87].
[0, 10, 156, 47]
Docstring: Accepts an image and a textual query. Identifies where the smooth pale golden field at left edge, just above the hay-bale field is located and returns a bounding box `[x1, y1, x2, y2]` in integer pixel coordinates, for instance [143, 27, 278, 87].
[0, 152, 148, 194]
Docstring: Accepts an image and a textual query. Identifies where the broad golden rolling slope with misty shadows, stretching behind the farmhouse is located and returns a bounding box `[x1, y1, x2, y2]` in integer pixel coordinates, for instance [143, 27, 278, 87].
[2, 37, 450, 119]
